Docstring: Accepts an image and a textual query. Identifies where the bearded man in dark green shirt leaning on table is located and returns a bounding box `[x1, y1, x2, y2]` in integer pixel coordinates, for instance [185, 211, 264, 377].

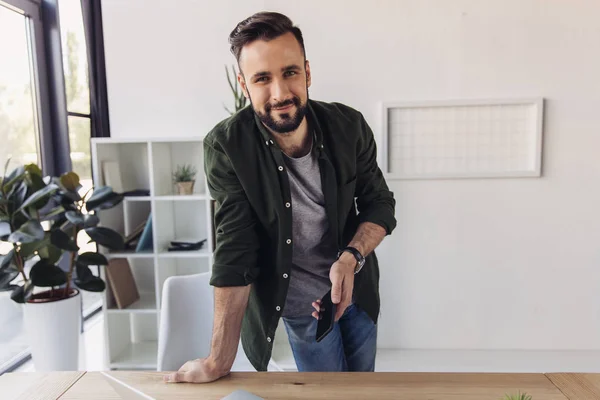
[165, 12, 396, 382]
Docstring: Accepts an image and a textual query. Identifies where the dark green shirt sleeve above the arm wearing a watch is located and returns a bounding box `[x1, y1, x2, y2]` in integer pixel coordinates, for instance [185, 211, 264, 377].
[355, 115, 396, 235]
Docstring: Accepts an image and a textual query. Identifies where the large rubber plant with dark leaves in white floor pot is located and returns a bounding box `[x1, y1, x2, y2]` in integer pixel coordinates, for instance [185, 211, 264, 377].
[0, 163, 123, 371]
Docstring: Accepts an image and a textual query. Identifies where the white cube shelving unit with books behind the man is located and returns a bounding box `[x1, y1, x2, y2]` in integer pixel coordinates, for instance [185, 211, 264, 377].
[92, 138, 213, 369]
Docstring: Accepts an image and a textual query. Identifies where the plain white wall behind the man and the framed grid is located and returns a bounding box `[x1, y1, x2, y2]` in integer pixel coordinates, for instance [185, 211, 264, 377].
[103, 0, 600, 349]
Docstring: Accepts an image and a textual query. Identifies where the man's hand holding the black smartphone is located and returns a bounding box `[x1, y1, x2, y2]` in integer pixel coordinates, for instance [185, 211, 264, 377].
[312, 252, 356, 321]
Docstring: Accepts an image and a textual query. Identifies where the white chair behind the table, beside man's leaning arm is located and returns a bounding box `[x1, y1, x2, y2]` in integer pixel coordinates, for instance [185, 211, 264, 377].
[157, 272, 281, 371]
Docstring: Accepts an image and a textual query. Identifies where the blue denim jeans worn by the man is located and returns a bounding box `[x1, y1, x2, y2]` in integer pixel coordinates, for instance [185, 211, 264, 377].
[283, 304, 377, 372]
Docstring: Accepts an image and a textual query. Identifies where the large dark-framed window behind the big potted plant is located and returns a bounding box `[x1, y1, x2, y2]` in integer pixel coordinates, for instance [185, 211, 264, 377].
[0, 0, 108, 374]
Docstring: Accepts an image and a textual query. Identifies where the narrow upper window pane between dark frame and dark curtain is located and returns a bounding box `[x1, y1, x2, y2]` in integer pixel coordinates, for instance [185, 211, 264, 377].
[58, 0, 90, 114]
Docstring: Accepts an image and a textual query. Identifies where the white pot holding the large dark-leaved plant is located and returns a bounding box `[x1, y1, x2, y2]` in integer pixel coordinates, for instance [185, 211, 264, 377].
[23, 289, 81, 371]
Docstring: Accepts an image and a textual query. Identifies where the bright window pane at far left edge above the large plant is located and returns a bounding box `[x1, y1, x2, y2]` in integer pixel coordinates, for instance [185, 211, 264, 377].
[0, 5, 40, 174]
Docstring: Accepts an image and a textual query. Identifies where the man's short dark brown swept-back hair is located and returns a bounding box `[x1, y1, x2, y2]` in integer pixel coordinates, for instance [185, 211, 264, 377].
[229, 11, 306, 63]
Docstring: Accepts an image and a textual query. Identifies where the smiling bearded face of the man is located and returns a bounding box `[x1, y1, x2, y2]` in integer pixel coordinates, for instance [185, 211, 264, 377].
[238, 33, 310, 134]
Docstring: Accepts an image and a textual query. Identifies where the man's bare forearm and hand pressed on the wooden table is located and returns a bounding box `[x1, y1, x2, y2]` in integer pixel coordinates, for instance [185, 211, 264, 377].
[165, 285, 250, 383]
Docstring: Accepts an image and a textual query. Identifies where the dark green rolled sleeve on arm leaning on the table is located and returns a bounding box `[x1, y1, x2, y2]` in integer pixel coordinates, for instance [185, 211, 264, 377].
[204, 136, 259, 287]
